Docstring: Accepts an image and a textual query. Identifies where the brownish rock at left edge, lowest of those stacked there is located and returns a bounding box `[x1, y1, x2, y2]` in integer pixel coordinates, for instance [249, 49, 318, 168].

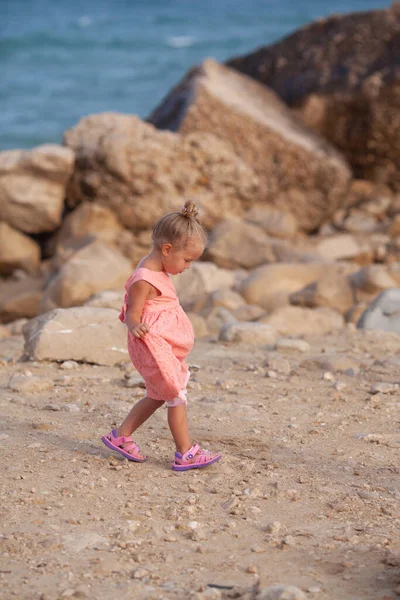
[0, 277, 44, 323]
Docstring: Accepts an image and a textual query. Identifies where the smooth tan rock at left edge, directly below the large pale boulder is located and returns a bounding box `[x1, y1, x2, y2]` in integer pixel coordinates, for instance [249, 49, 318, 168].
[0, 222, 40, 275]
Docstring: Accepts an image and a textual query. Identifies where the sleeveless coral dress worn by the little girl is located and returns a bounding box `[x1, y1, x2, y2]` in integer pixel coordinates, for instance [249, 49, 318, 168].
[119, 267, 194, 406]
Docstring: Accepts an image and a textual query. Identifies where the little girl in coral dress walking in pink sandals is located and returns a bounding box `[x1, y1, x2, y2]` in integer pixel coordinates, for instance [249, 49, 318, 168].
[102, 200, 221, 471]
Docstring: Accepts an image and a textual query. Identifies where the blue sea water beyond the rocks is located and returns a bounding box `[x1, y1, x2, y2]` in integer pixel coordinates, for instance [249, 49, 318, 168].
[0, 0, 390, 149]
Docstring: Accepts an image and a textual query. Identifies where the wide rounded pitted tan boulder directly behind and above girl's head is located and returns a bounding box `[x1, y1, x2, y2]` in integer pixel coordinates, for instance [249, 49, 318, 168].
[64, 113, 261, 231]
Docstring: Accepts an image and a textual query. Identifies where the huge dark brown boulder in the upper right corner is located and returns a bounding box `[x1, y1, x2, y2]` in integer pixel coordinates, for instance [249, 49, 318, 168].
[228, 2, 400, 190]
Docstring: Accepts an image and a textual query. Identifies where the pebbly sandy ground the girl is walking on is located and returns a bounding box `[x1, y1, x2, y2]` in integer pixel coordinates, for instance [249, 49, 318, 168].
[0, 329, 400, 600]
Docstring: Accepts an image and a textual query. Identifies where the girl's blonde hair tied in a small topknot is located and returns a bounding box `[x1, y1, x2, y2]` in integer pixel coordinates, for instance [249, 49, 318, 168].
[152, 200, 207, 248]
